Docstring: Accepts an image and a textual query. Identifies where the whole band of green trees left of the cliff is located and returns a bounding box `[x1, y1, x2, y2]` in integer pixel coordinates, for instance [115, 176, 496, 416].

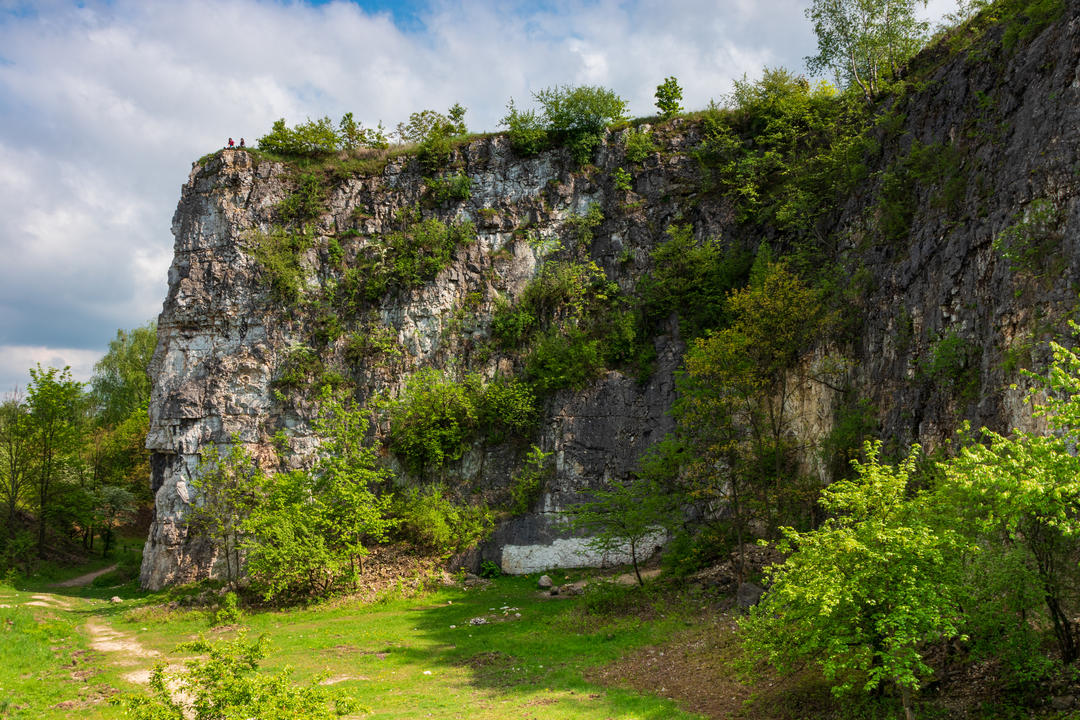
[0, 323, 157, 572]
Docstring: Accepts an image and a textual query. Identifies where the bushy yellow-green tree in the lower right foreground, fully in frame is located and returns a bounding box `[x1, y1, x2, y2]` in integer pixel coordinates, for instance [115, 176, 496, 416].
[741, 443, 960, 720]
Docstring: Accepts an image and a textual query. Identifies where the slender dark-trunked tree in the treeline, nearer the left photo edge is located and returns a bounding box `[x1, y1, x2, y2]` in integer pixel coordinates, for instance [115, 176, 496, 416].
[27, 365, 83, 556]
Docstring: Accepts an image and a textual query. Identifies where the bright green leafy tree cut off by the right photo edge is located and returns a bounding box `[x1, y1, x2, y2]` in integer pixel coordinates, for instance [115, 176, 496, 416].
[939, 338, 1080, 671]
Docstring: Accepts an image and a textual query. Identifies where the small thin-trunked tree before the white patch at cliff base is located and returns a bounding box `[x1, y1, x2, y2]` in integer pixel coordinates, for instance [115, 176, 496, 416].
[567, 478, 679, 585]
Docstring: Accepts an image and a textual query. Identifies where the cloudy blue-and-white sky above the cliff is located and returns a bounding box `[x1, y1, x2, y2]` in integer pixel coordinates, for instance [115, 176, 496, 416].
[0, 0, 955, 394]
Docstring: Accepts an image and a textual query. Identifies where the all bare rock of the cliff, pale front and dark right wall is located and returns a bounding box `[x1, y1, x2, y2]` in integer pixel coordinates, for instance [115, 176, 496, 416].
[141, 3, 1080, 588]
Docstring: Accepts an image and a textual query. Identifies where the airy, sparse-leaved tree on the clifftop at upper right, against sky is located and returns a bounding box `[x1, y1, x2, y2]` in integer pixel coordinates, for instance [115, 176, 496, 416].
[806, 0, 929, 100]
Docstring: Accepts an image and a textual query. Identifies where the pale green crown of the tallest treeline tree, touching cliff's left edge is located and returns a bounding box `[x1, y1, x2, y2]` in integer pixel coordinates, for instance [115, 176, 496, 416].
[90, 321, 158, 425]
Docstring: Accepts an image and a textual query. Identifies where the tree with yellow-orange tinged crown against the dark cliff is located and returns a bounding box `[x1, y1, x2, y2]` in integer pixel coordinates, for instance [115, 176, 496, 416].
[675, 259, 832, 561]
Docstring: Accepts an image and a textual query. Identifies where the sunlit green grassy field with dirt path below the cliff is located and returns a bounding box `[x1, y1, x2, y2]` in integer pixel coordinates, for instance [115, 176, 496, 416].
[0, 561, 701, 720]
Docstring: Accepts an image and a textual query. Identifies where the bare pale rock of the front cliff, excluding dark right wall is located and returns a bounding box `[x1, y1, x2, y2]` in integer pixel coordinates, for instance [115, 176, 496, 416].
[141, 138, 680, 588]
